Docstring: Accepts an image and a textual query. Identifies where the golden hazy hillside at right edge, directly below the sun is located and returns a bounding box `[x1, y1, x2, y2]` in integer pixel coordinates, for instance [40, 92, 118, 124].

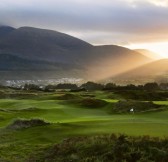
[114, 59, 168, 83]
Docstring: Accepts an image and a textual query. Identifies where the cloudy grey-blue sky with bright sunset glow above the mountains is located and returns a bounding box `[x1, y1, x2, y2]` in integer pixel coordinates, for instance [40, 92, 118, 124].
[0, 0, 168, 58]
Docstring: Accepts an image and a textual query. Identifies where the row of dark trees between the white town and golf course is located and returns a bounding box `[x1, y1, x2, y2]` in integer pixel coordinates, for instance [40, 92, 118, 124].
[22, 81, 168, 92]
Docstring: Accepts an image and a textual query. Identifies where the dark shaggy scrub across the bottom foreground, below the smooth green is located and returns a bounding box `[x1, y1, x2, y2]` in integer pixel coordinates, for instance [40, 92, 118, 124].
[30, 134, 168, 162]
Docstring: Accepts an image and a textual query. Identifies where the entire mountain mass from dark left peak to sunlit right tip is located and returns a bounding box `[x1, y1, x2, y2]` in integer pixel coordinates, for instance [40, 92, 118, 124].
[0, 27, 151, 80]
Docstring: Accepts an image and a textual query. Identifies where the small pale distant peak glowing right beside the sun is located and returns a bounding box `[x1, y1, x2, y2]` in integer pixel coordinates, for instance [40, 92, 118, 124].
[134, 49, 162, 60]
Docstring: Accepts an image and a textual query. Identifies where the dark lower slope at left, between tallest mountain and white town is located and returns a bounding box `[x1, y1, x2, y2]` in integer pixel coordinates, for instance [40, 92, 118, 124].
[0, 54, 85, 80]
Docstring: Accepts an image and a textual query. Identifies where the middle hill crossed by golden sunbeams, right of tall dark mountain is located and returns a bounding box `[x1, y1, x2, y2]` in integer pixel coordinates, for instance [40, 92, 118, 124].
[85, 45, 151, 79]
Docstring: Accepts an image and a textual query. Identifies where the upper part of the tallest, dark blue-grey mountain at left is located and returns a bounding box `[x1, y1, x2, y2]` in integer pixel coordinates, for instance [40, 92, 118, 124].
[0, 27, 91, 62]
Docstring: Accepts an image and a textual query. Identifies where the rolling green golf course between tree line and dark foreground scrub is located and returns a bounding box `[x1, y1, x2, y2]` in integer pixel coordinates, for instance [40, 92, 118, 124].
[0, 86, 168, 162]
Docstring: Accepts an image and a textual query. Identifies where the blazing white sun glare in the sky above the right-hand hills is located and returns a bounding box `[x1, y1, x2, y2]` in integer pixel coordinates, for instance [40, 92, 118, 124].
[125, 42, 168, 58]
